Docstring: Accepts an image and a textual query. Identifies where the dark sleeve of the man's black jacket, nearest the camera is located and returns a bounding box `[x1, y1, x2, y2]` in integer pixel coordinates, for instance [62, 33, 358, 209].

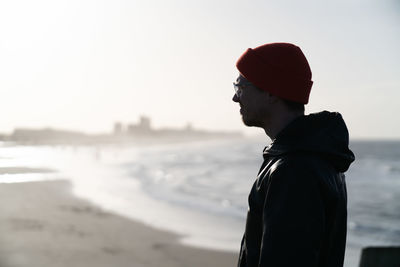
[259, 160, 325, 267]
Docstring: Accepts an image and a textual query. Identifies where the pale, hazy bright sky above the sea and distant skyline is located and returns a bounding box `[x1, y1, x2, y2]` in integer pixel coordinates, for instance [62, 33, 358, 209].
[0, 0, 400, 139]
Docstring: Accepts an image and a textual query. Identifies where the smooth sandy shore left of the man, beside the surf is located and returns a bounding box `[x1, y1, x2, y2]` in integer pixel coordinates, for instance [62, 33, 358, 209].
[0, 181, 239, 267]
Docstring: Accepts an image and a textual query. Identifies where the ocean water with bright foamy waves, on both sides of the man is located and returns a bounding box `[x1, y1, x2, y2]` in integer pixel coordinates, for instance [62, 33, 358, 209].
[0, 138, 400, 267]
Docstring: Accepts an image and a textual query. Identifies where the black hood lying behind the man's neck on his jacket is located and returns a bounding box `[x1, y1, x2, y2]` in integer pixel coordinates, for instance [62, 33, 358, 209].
[264, 111, 354, 172]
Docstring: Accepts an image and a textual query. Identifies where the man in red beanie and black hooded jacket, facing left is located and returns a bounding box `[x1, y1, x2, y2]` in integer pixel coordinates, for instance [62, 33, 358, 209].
[233, 43, 354, 267]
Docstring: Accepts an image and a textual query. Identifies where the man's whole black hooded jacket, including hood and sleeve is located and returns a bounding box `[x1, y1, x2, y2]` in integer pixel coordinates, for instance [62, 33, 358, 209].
[238, 111, 354, 267]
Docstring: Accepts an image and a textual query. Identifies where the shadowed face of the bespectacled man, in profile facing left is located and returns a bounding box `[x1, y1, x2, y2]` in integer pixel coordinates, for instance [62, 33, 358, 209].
[232, 75, 269, 127]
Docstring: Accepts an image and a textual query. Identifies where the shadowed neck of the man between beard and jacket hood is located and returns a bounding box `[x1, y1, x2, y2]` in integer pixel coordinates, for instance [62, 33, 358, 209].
[263, 112, 304, 141]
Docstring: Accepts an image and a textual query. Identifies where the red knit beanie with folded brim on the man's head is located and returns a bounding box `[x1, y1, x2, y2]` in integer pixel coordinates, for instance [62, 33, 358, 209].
[236, 43, 313, 104]
